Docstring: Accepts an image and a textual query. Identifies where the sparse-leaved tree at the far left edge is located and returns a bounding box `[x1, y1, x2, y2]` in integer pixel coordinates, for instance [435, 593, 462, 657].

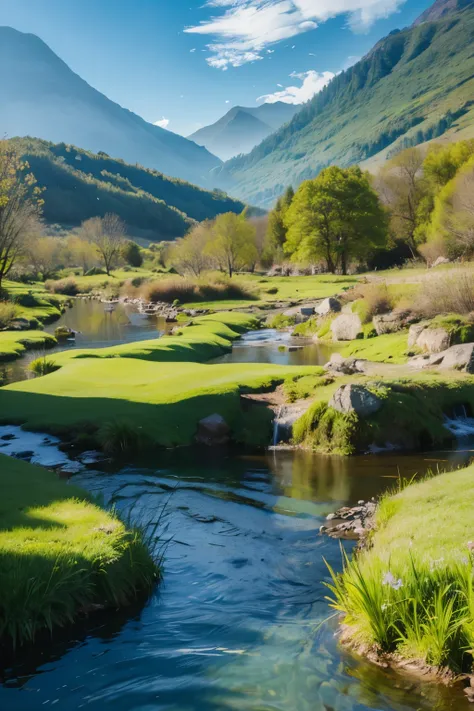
[0, 141, 42, 292]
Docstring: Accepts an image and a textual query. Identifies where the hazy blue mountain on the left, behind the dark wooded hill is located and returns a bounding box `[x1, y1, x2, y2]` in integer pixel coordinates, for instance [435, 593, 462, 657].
[0, 27, 220, 187]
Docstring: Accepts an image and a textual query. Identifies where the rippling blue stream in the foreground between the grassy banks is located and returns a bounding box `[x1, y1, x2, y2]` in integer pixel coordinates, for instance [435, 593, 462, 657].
[0, 302, 472, 711]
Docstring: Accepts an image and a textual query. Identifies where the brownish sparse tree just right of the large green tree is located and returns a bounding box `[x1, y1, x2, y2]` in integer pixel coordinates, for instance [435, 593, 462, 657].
[376, 148, 430, 257]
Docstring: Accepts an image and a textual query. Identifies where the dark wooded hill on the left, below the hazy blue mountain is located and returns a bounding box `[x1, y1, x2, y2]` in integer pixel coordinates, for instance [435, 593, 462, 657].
[12, 138, 244, 240]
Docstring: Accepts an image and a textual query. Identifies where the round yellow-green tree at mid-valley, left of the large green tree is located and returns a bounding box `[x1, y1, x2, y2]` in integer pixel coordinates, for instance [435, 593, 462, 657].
[206, 212, 258, 277]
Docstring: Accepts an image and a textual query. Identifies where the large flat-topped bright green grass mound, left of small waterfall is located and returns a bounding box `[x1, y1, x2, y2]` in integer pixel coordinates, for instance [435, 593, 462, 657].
[0, 357, 320, 446]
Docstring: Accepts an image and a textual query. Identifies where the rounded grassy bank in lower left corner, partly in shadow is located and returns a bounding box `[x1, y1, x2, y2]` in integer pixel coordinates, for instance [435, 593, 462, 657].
[0, 455, 158, 644]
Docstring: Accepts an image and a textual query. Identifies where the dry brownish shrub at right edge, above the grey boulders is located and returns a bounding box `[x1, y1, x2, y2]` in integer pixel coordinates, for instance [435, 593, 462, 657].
[412, 272, 474, 318]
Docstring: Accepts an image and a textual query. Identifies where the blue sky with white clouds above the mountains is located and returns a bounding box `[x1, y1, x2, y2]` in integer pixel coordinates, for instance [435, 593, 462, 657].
[0, 0, 431, 135]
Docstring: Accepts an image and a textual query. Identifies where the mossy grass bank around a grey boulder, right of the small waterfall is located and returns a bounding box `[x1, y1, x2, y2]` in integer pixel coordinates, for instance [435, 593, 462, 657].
[293, 376, 474, 455]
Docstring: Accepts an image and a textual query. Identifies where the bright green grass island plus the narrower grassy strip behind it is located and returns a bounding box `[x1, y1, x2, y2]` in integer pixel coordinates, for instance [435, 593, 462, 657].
[0, 313, 322, 453]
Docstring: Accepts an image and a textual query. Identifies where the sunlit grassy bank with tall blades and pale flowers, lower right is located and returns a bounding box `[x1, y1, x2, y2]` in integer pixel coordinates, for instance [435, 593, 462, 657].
[332, 466, 474, 673]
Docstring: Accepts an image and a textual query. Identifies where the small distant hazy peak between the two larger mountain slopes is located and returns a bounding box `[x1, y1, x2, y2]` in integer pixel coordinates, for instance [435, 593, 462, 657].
[188, 101, 298, 160]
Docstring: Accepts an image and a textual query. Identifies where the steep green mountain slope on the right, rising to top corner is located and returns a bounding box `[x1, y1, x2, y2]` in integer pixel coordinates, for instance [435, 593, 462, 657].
[214, 0, 474, 206]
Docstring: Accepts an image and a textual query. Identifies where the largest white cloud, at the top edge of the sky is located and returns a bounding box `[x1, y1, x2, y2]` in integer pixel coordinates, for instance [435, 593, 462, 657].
[185, 0, 406, 70]
